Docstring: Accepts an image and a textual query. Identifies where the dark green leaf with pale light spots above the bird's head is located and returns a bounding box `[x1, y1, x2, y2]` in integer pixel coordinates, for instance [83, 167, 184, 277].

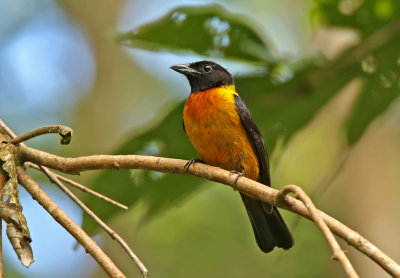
[116, 5, 271, 61]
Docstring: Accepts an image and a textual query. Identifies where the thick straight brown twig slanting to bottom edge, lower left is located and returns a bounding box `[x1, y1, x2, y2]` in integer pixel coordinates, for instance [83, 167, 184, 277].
[17, 167, 126, 278]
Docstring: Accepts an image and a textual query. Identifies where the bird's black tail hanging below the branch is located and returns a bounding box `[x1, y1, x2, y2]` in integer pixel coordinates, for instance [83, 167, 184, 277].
[240, 194, 294, 253]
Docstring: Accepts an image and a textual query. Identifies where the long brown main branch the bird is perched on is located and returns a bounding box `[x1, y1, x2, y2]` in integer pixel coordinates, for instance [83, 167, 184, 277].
[16, 146, 400, 277]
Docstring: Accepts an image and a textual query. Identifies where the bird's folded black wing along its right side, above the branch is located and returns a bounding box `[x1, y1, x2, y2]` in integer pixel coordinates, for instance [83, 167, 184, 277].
[234, 95, 271, 186]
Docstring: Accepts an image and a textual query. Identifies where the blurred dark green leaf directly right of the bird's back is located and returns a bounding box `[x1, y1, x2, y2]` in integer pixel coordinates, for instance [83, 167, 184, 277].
[236, 63, 361, 150]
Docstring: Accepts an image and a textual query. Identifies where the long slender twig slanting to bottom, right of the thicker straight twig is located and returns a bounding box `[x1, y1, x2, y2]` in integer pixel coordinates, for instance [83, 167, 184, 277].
[39, 166, 149, 277]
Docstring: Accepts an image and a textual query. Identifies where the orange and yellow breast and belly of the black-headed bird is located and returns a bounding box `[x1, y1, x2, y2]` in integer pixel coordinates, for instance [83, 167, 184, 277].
[183, 86, 259, 180]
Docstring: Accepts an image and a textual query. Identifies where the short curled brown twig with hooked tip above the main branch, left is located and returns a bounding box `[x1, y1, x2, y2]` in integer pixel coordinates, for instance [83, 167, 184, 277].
[6, 124, 72, 145]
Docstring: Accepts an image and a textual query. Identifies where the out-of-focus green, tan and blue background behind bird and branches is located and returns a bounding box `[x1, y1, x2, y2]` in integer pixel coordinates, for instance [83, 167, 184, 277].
[0, 0, 400, 278]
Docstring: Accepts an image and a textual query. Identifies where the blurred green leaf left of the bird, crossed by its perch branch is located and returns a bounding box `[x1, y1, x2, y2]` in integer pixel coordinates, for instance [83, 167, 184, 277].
[83, 104, 202, 233]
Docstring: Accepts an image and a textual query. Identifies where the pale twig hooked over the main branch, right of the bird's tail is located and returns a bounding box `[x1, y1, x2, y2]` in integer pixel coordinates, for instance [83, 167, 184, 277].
[280, 184, 359, 278]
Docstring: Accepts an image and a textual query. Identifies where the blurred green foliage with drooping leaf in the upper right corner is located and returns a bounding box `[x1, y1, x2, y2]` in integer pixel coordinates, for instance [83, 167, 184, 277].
[314, 0, 400, 143]
